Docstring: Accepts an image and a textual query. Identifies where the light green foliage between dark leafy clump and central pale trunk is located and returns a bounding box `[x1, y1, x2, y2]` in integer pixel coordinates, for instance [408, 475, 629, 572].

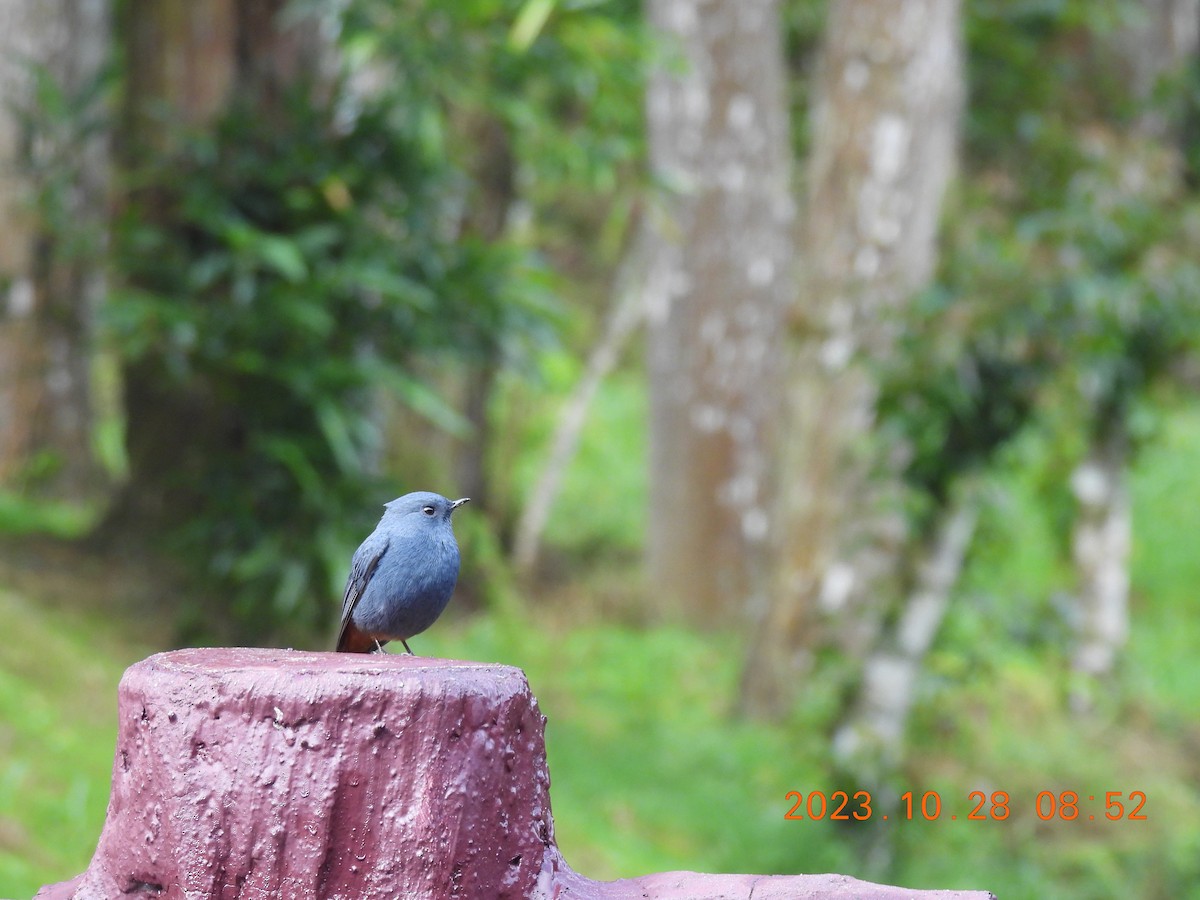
[331, 0, 653, 556]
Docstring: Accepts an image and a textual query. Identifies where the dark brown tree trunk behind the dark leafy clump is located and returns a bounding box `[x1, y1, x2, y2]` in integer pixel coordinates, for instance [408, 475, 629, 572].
[104, 0, 328, 534]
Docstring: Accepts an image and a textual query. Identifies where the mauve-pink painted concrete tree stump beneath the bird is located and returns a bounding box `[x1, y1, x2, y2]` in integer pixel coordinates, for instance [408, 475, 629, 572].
[37, 649, 990, 900]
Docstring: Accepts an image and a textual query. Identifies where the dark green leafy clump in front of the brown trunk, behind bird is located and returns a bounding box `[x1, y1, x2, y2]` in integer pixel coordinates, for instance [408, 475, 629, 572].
[106, 81, 546, 634]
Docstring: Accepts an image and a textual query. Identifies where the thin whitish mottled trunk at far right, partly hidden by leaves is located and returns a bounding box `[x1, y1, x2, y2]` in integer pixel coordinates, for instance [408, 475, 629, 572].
[1070, 0, 1200, 712]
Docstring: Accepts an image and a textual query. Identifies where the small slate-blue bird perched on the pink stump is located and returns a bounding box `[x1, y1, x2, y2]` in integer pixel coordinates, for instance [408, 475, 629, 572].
[335, 491, 470, 655]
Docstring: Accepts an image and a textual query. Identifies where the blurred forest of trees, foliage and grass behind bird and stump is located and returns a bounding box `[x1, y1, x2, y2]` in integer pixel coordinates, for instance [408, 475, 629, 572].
[0, 0, 1200, 898]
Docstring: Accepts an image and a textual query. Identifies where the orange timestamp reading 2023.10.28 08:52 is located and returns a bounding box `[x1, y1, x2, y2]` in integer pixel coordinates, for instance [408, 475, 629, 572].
[784, 791, 1147, 822]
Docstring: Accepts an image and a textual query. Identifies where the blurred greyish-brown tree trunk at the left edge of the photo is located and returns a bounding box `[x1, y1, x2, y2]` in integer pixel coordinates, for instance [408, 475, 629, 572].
[0, 0, 109, 500]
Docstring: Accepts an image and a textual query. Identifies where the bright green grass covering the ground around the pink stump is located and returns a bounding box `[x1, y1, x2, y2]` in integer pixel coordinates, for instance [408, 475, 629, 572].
[7, 397, 1200, 900]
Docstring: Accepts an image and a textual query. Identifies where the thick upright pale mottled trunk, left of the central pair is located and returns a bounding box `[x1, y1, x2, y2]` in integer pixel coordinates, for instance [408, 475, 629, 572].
[646, 0, 794, 626]
